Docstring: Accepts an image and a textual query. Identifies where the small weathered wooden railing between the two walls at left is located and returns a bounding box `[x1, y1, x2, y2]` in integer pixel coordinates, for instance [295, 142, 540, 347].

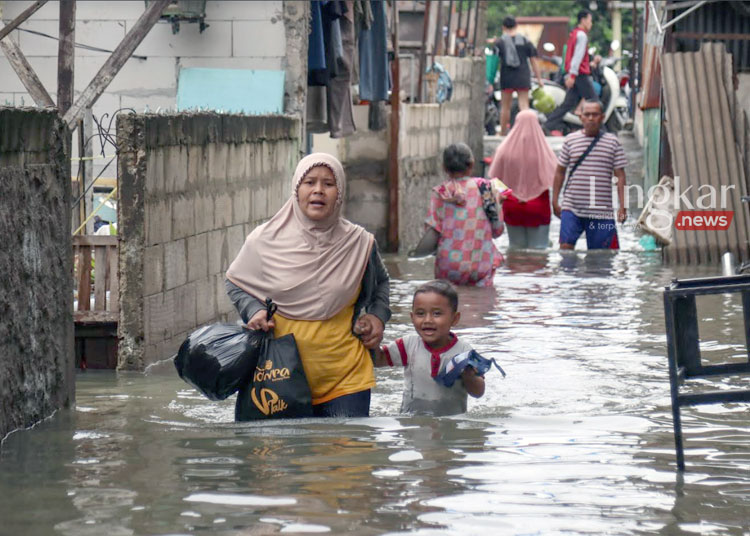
[73, 235, 120, 322]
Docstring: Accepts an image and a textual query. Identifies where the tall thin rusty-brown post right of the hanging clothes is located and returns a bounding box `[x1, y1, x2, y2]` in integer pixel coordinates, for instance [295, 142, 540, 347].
[388, 2, 402, 253]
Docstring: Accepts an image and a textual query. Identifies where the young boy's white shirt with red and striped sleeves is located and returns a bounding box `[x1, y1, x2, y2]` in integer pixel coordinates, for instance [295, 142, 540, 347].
[383, 335, 472, 415]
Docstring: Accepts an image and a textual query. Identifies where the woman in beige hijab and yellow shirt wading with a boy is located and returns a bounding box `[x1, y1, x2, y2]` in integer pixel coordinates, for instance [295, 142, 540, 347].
[226, 153, 391, 417]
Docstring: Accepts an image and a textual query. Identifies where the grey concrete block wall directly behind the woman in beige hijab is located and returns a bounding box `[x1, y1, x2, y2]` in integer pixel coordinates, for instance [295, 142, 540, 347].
[117, 113, 300, 370]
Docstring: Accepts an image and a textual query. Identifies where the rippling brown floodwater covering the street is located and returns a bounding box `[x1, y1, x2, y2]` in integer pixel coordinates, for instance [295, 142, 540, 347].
[0, 229, 750, 536]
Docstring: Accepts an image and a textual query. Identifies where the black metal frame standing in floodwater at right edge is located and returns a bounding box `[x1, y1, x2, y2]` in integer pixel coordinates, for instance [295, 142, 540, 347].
[664, 275, 750, 471]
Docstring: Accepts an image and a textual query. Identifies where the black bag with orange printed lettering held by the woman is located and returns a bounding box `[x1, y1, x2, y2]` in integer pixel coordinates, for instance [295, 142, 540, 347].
[234, 300, 313, 421]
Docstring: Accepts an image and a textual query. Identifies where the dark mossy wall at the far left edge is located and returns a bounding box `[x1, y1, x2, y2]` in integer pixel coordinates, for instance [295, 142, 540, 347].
[0, 107, 75, 440]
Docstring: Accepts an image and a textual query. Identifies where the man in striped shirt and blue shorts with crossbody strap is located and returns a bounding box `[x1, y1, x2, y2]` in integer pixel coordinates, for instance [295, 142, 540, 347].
[552, 101, 627, 249]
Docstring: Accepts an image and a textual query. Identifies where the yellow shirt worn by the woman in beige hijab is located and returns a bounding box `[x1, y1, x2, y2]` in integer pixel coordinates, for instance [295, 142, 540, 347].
[274, 293, 375, 404]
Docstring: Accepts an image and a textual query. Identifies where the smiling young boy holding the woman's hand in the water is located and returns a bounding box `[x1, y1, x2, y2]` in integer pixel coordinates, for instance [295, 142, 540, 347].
[375, 279, 484, 415]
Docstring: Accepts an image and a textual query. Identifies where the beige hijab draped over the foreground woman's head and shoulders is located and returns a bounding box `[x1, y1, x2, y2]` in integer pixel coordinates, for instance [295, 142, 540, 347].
[227, 153, 374, 320]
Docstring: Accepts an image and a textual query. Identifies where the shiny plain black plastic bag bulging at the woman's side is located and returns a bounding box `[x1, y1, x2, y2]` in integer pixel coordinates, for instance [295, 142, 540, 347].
[174, 324, 265, 400]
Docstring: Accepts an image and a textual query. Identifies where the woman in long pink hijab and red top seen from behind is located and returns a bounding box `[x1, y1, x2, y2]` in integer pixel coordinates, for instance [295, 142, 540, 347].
[489, 110, 557, 249]
